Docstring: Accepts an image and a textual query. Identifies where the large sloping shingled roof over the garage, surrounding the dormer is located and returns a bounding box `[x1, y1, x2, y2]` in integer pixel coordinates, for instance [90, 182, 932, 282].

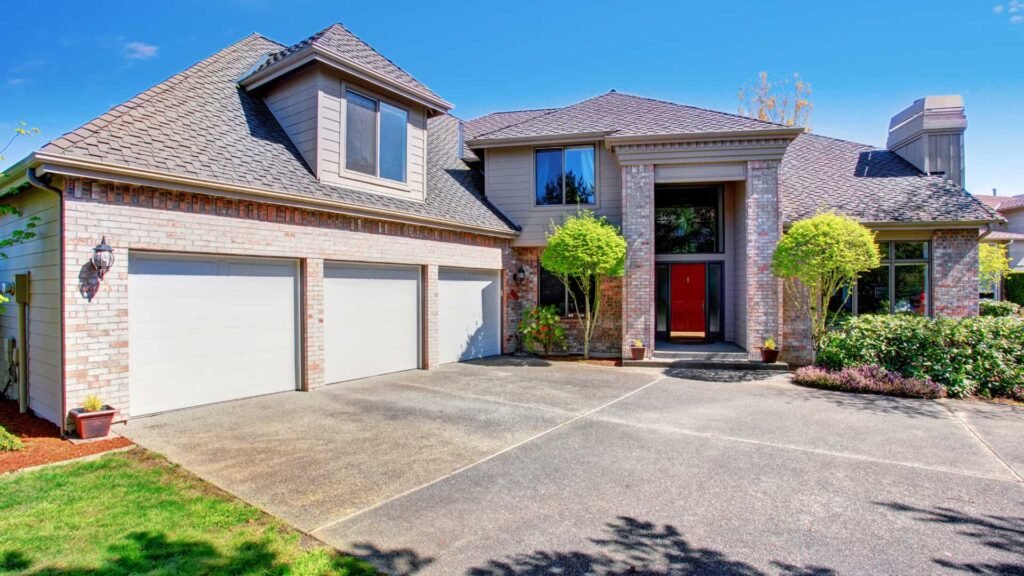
[40, 35, 515, 233]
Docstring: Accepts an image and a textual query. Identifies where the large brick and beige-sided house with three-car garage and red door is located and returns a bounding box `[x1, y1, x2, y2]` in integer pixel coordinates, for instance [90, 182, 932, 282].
[0, 26, 998, 422]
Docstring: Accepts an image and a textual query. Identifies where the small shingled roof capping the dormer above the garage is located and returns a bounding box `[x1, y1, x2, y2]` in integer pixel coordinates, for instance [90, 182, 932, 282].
[242, 24, 452, 109]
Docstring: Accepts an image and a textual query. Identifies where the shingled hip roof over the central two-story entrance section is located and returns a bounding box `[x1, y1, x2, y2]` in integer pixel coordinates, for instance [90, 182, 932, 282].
[469, 90, 792, 145]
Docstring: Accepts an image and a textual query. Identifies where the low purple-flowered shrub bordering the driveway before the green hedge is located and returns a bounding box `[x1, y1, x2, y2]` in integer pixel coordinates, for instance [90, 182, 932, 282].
[793, 366, 946, 398]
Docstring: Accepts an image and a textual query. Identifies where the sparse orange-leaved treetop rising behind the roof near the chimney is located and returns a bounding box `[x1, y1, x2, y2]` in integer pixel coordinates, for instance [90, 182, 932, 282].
[736, 72, 814, 127]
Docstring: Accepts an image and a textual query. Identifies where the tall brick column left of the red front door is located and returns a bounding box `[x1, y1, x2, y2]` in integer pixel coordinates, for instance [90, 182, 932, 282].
[622, 164, 654, 358]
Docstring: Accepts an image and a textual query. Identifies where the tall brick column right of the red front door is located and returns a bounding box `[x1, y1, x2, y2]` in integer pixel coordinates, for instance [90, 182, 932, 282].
[745, 160, 785, 360]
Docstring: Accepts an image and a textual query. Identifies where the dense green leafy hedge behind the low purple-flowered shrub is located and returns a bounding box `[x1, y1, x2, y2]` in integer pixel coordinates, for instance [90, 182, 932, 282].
[817, 315, 1024, 399]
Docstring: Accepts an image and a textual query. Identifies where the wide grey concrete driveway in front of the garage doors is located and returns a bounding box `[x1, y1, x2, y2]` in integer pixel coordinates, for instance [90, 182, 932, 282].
[121, 359, 1024, 576]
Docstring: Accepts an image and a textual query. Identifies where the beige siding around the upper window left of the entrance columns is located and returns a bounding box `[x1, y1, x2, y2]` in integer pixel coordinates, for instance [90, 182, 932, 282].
[484, 142, 623, 246]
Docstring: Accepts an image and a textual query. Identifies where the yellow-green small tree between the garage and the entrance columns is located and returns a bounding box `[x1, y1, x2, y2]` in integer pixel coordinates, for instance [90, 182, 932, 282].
[541, 210, 626, 358]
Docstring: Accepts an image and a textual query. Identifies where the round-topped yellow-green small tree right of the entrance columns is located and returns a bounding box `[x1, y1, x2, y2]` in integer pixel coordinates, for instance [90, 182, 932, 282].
[771, 212, 881, 352]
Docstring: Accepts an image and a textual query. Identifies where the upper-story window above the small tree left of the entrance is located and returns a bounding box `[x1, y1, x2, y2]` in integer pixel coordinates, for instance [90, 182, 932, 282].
[534, 146, 597, 206]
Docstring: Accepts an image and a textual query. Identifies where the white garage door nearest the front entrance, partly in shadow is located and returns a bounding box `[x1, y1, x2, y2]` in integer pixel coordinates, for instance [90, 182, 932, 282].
[438, 269, 502, 363]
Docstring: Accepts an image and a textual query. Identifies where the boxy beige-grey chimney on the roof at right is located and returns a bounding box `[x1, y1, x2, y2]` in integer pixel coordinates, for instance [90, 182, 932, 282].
[886, 95, 967, 187]
